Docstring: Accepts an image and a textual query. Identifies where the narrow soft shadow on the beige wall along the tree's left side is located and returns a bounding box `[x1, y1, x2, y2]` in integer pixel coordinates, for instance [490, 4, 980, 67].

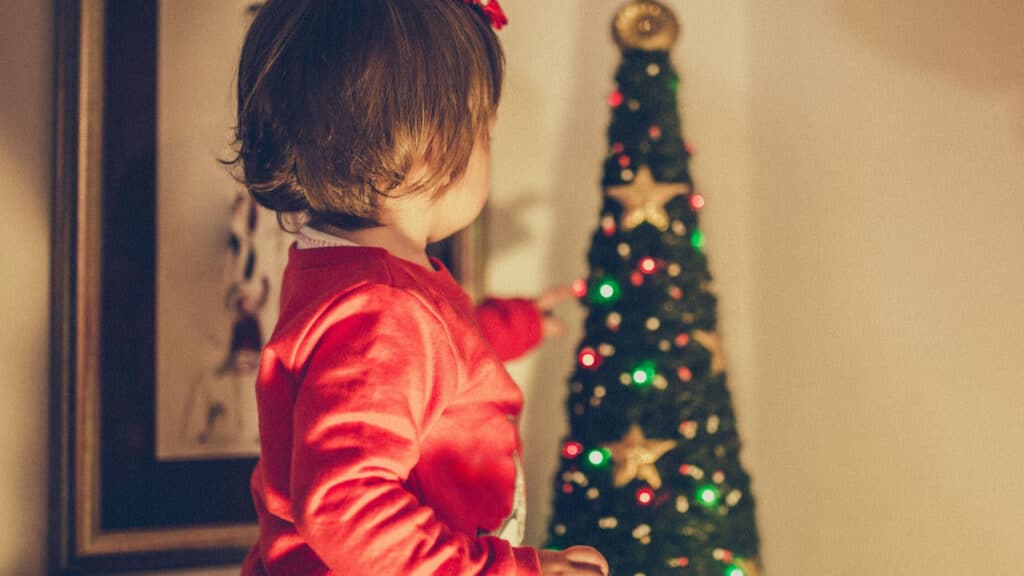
[522, 0, 620, 545]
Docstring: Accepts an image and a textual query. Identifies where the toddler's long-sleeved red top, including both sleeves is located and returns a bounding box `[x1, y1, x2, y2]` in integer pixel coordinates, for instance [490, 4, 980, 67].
[243, 242, 541, 576]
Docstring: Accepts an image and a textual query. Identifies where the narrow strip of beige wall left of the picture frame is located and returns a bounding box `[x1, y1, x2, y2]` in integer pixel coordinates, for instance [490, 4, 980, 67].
[0, 1, 53, 574]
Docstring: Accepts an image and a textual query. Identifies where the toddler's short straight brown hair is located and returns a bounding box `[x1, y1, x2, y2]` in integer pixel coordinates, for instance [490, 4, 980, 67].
[231, 0, 504, 229]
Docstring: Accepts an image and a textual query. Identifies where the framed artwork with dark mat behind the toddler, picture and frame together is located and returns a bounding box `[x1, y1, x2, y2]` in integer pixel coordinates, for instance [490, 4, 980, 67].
[50, 0, 481, 574]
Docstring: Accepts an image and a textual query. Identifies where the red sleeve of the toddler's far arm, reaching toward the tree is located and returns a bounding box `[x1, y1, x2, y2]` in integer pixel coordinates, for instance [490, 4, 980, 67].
[476, 298, 543, 362]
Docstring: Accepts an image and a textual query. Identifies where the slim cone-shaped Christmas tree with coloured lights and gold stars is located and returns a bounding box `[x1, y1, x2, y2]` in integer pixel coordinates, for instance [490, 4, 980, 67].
[549, 0, 759, 576]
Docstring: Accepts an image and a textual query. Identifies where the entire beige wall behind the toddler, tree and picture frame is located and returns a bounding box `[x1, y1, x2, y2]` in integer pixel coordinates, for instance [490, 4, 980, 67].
[0, 0, 1024, 576]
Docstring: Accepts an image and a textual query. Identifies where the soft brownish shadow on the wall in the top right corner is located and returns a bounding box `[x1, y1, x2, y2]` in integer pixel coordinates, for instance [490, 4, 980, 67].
[831, 0, 1024, 118]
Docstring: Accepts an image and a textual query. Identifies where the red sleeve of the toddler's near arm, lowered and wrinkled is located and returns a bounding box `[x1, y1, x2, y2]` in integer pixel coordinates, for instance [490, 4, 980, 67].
[291, 287, 540, 576]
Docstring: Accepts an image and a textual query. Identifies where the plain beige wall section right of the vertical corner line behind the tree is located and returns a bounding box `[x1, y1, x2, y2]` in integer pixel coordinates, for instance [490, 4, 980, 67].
[745, 0, 1024, 576]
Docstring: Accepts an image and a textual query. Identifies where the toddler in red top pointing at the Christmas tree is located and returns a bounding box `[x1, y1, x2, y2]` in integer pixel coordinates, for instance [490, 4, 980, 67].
[237, 0, 608, 576]
